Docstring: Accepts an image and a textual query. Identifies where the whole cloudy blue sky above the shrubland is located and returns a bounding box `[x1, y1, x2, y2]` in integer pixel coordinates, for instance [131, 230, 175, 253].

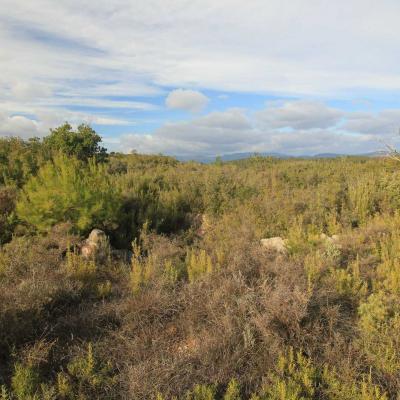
[0, 0, 400, 157]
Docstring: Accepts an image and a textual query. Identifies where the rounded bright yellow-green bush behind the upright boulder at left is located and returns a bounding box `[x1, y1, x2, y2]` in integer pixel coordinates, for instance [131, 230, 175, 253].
[17, 156, 120, 232]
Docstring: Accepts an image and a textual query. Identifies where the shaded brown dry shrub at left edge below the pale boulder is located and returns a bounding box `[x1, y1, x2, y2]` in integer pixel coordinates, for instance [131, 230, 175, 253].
[0, 227, 121, 390]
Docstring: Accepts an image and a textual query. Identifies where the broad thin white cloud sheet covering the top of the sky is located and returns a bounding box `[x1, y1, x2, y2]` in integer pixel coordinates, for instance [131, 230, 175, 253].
[0, 0, 400, 104]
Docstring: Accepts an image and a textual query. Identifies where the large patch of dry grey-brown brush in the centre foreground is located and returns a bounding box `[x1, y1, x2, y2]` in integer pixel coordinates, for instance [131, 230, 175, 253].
[104, 236, 334, 399]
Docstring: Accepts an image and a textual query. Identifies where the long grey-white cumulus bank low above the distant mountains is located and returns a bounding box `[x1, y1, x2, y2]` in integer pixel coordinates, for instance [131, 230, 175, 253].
[114, 102, 386, 157]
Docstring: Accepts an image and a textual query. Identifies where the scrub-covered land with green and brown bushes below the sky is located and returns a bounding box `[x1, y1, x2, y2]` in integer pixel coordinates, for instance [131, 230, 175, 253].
[0, 130, 400, 400]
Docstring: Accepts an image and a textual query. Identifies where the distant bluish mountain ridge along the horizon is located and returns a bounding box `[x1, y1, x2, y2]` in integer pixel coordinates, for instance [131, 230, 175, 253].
[175, 151, 388, 164]
